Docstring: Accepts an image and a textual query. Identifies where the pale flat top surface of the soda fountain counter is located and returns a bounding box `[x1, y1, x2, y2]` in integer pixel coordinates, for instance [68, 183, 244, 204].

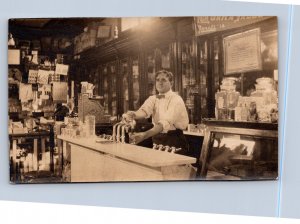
[57, 135, 196, 167]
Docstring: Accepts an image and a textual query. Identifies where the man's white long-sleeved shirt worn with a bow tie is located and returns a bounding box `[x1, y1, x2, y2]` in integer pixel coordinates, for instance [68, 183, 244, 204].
[139, 90, 189, 133]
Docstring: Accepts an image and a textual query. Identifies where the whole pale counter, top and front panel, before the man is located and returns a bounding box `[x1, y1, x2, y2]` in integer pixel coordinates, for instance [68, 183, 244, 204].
[58, 136, 196, 182]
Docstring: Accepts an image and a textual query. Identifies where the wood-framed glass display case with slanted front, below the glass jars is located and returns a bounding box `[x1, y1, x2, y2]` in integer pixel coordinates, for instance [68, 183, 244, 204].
[200, 122, 278, 180]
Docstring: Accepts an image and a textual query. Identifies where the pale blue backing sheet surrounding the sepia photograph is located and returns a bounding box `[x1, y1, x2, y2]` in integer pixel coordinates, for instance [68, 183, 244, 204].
[0, 0, 300, 218]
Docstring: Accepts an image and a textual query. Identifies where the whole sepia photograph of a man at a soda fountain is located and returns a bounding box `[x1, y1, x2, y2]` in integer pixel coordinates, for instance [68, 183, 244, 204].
[7, 16, 279, 184]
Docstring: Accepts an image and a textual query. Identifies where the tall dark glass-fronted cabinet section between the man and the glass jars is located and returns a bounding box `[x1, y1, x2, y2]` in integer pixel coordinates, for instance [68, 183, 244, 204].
[181, 38, 212, 124]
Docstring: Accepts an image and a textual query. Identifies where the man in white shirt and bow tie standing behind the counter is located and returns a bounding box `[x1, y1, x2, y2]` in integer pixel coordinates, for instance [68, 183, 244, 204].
[123, 70, 189, 154]
